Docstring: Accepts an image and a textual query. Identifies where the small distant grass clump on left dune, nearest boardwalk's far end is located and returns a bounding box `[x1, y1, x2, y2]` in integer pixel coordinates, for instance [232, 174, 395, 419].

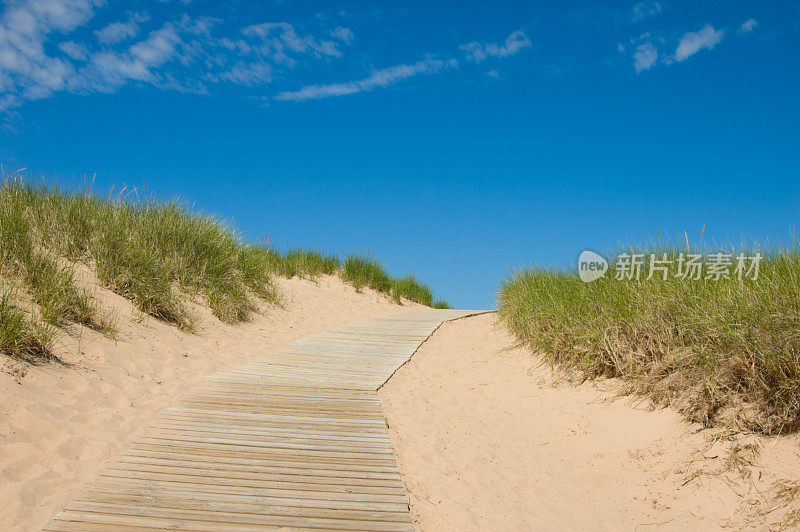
[339, 255, 450, 308]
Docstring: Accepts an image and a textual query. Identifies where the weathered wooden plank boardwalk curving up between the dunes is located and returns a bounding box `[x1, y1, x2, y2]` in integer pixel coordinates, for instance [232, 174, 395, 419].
[45, 310, 484, 531]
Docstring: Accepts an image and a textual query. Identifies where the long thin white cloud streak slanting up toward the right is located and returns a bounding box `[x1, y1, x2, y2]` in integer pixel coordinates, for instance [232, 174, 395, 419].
[275, 59, 456, 102]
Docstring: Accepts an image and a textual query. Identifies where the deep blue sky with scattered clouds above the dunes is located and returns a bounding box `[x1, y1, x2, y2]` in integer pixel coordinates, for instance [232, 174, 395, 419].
[0, 0, 800, 307]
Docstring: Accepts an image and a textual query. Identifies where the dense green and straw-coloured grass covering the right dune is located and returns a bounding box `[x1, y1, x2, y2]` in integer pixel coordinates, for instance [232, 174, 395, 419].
[498, 247, 800, 434]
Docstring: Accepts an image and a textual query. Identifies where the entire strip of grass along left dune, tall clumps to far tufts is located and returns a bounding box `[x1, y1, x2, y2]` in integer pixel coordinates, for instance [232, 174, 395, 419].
[0, 179, 450, 362]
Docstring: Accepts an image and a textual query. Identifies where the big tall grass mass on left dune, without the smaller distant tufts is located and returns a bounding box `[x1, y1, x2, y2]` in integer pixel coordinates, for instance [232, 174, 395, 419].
[0, 180, 277, 330]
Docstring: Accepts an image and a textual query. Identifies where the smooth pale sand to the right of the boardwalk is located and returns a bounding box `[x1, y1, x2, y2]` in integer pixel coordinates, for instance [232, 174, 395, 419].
[380, 315, 800, 530]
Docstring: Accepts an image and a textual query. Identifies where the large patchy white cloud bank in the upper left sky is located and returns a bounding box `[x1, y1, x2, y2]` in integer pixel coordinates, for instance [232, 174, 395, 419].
[0, 0, 355, 112]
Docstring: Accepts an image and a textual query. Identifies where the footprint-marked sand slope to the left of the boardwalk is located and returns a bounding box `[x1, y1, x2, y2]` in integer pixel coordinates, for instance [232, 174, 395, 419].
[0, 269, 419, 530]
